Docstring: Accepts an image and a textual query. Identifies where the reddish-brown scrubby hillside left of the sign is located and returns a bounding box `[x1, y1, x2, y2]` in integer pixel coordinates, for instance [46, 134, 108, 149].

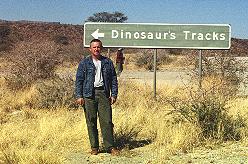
[0, 19, 84, 62]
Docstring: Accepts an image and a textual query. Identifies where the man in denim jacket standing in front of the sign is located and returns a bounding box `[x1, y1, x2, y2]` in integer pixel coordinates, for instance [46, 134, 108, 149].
[75, 39, 119, 155]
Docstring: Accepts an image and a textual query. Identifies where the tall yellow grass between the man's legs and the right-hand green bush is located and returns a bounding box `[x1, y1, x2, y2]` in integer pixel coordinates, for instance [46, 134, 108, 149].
[115, 81, 200, 156]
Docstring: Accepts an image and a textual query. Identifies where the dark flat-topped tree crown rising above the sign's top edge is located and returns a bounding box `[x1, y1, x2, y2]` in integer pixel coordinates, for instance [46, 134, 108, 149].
[86, 11, 128, 23]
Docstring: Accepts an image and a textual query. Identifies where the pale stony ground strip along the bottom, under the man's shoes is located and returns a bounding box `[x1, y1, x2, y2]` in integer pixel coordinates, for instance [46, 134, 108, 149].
[65, 143, 248, 164]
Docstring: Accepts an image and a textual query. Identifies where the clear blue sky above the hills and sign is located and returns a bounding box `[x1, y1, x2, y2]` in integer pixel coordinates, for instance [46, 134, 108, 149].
[0, 0, 248, 39]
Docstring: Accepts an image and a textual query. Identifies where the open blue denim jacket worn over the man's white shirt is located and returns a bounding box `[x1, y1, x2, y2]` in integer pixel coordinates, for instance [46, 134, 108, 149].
[75, 56, 118, 98]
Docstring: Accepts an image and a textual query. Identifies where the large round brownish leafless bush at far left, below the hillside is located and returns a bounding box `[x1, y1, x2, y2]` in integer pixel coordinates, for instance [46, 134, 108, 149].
[6, 42, 61, 90]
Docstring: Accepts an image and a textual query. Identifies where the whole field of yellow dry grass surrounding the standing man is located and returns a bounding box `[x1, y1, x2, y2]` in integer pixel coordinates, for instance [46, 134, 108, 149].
[0, 53, 248, 164]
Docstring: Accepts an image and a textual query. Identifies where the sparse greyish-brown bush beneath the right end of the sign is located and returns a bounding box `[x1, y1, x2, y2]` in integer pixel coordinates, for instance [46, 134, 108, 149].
[191, 50, 247, 95]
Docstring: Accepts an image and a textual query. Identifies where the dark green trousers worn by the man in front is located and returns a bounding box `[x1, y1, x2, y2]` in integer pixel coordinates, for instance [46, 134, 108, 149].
[84, 90, 114, 149]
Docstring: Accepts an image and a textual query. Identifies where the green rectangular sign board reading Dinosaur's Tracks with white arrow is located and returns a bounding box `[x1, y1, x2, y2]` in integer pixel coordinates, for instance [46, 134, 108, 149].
[84, 22, 231, 49]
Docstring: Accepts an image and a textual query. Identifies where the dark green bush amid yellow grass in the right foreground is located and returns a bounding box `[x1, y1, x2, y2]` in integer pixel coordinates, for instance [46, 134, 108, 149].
[167, 87, 246, 141]
